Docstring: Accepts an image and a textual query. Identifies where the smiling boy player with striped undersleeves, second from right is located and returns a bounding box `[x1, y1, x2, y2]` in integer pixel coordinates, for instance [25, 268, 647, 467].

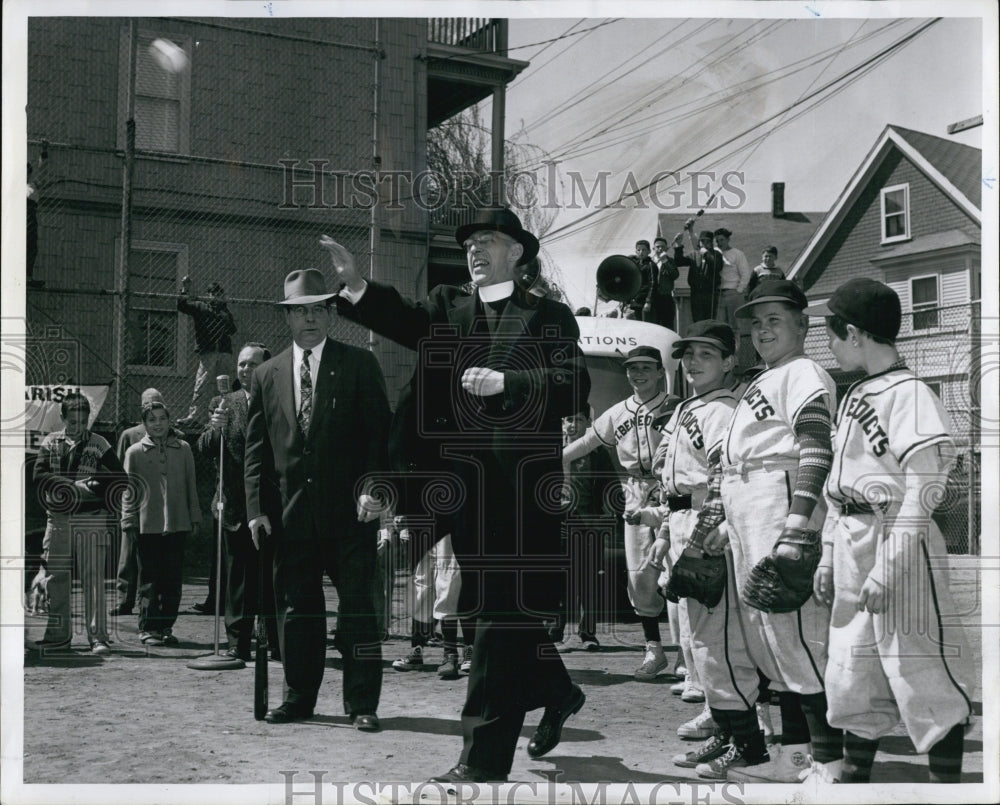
[668, 280, 843, 782]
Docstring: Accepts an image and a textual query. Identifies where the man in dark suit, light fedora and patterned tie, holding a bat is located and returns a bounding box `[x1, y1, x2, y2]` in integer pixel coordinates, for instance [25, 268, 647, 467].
[244, 268, 389, 732]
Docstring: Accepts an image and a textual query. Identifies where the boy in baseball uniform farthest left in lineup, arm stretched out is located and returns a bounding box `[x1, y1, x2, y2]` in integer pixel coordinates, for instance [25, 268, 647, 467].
[563, 346, 676, 682]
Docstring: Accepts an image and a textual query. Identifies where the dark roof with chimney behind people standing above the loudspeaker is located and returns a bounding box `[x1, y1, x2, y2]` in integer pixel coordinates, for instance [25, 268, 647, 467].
[657, 210, 824, 267]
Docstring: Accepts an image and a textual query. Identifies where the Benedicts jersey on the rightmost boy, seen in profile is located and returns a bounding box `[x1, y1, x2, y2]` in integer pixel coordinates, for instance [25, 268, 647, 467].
[826, 366, 954, 506]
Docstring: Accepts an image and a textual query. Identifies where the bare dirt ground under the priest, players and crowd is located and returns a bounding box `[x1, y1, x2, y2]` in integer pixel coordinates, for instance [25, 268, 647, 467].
[11, 556, 983, 803]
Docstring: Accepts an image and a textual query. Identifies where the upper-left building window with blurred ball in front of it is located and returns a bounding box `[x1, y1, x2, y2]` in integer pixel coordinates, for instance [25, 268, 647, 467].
[118, 26, 191, 154]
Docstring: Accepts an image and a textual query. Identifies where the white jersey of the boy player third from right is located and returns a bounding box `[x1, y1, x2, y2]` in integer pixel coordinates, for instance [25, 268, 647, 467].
[653, 388, 739, 496]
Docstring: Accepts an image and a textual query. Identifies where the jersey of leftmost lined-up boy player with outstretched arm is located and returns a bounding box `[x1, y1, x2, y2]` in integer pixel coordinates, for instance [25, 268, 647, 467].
[583, 391, 676, 477]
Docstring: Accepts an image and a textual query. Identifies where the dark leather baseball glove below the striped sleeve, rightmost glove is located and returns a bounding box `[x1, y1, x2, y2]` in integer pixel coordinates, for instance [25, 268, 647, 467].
[742, 528, 823, 612]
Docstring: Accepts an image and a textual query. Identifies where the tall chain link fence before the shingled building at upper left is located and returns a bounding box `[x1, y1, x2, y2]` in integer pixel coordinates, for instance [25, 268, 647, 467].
[26, 18, 380, 431]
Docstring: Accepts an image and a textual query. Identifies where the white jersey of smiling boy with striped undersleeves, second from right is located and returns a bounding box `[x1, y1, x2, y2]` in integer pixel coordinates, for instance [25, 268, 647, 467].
[722, 355, 837, 466]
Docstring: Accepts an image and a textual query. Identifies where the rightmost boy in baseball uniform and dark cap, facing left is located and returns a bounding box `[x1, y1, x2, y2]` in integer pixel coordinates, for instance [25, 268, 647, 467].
[806, 278, 972, 783]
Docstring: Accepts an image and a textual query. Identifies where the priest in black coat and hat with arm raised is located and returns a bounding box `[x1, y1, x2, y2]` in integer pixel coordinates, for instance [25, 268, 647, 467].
[320, 209, 590, 783]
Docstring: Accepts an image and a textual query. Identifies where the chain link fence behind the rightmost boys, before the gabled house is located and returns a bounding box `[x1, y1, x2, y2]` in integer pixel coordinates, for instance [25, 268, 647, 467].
[806, 302, 983, 554]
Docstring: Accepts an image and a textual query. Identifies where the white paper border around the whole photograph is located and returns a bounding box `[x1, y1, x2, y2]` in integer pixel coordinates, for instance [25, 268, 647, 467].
[0, 0, 1000, 805]
